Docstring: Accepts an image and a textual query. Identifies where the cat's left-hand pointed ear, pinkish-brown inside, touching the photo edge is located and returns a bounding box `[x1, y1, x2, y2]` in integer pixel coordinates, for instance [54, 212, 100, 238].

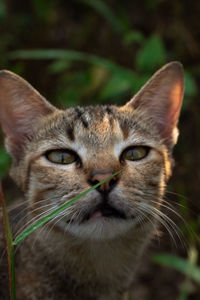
[0, 71, 56, 159]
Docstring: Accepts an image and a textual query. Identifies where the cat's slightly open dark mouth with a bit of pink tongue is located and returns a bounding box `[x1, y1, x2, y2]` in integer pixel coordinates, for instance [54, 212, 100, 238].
[82, 204, 126, 222]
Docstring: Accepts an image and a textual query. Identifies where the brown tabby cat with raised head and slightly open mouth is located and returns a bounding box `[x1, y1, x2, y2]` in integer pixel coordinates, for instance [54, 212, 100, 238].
[0, 62, 184, 300]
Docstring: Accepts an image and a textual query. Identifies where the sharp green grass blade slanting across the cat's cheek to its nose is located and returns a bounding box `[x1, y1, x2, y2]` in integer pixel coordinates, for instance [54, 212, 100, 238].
[13, 170, 122, 245]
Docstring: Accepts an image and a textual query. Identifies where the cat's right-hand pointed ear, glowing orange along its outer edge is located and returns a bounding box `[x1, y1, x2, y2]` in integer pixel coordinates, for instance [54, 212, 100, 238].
[126, 62, 184, 148]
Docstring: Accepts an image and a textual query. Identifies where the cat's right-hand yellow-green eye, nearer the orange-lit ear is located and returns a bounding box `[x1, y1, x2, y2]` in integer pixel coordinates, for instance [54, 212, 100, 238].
[121, 146, 149, 161]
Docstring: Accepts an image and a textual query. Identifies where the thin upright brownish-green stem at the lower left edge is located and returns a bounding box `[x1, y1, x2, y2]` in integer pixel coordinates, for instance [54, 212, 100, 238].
[0, 181, 16, 300]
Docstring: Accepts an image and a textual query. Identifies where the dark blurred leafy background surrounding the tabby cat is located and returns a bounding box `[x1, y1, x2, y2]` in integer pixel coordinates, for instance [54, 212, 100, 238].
[0, 0, 200, 300]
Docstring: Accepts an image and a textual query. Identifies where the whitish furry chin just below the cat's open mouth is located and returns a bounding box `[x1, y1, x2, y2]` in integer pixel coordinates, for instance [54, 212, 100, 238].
[61, 217, 138, 240]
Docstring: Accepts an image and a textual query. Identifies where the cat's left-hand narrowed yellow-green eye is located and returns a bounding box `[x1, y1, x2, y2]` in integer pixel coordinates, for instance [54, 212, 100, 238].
[46, 150, 77, 165]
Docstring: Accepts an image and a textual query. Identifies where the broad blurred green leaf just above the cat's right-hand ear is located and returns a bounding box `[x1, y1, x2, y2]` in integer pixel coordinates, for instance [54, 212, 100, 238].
[136, 35, 166, 72]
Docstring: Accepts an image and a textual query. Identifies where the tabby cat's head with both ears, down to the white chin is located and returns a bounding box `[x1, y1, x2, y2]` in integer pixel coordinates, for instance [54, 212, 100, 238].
[0, 63, 183, 239]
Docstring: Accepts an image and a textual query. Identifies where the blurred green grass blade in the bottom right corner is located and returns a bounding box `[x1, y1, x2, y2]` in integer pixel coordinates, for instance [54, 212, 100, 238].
[153, 254, 200, 284]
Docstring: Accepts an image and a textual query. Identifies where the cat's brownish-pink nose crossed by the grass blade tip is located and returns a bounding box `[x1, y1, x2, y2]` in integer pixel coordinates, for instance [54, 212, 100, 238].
[89, 171, 118, 193]
